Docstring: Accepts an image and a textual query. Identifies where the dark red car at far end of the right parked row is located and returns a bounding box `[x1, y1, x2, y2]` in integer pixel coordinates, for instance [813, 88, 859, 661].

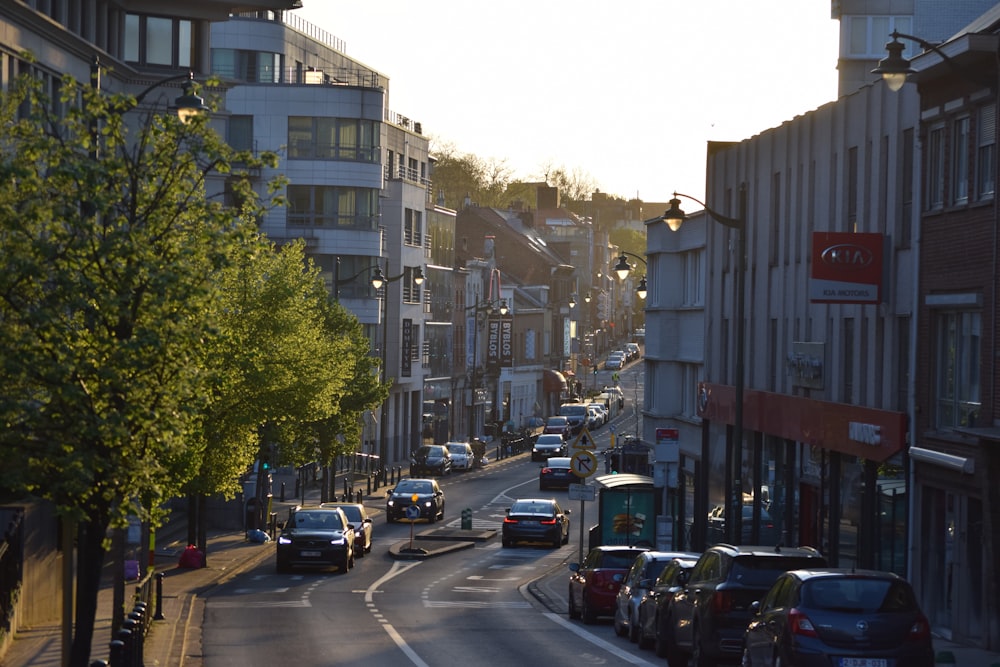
[568, 545, 646, 625]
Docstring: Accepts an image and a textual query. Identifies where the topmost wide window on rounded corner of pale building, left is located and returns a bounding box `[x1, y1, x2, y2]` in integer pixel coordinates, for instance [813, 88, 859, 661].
[288, 116, 379, 162]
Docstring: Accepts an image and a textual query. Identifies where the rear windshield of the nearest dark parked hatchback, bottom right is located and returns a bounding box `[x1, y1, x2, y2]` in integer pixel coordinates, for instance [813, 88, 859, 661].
[802, 577, 916, 613]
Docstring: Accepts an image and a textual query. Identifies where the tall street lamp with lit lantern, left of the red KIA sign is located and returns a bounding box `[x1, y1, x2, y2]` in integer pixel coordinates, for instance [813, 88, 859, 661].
[659, 185, 744, 544]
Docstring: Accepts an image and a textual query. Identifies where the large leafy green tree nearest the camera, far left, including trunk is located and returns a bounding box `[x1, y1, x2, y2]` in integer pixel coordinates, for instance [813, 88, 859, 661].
[0, 66, 274, 667]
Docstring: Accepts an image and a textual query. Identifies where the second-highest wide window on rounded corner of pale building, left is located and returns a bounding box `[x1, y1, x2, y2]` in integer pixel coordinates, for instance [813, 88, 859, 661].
[287, 185, 378, 230]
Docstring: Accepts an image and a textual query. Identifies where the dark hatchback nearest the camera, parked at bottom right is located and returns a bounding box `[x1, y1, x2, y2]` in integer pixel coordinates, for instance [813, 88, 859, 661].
[743, 569, 934, 667]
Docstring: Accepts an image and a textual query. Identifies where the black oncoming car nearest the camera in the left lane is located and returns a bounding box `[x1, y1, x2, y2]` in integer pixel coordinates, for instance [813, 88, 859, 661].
[275, 507, 355, 573]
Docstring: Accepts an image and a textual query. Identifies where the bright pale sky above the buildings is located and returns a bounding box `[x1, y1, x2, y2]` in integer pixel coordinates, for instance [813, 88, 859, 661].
[295, 0, 840, 202]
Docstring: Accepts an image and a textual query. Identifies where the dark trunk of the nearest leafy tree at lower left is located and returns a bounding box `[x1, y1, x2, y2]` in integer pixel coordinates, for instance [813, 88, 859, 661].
[70, 517, 110, 667]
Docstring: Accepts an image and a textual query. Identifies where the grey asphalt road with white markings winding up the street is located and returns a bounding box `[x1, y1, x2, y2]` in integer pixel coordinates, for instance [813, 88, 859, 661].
[202, 366, 660, 667]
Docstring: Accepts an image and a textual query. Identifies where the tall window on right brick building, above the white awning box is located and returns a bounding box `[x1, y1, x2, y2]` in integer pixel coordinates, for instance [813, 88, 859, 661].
[934, 311, 982, 428]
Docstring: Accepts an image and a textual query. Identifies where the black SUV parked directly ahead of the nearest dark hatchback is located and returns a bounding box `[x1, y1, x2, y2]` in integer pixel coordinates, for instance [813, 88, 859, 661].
[666, 544, 826, 667]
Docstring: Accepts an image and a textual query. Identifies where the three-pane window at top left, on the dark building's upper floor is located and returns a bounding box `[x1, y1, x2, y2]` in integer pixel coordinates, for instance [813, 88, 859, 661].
[122, 14, 195, 67]
